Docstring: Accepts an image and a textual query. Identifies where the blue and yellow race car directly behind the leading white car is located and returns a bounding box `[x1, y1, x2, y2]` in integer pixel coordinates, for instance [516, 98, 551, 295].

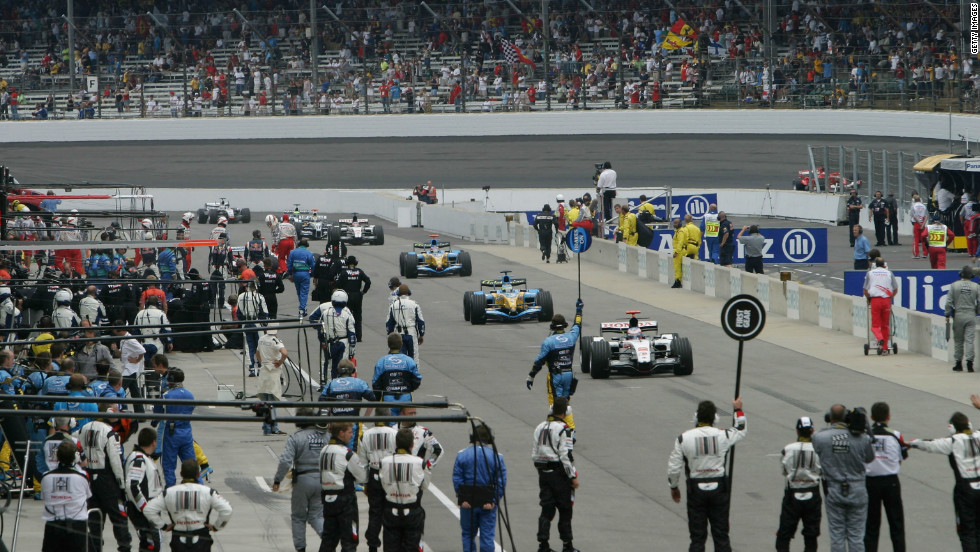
[463, 270, 555, 324]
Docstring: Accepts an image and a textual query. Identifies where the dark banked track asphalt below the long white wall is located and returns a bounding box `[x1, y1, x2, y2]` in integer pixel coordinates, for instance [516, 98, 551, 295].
[0, 134, 948, 189]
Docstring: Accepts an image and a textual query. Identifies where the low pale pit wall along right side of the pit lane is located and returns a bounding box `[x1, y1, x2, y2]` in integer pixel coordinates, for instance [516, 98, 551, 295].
[510, 223, 952, 362]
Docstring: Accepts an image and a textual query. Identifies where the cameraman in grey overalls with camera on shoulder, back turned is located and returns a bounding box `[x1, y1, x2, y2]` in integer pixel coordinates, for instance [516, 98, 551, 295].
[813, 404, 875, 551]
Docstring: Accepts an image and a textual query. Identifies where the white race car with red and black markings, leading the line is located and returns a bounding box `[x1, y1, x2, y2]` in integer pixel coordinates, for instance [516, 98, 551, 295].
[579, 311, 694, 379]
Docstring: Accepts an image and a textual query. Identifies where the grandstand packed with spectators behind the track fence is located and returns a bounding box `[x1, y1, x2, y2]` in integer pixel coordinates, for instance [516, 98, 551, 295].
[0, 0, 980, 118]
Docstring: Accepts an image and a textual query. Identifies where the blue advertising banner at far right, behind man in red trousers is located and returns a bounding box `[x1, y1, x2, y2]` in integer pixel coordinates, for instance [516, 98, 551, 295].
[844, 270, 960, 315]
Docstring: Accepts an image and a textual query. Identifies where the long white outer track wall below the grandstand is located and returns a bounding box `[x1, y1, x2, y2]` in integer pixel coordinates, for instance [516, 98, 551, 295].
[2, 109, 980, 143]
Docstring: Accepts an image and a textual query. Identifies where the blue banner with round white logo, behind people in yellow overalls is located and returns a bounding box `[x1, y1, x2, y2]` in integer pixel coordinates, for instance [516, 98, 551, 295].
[650, 228, 827, 264]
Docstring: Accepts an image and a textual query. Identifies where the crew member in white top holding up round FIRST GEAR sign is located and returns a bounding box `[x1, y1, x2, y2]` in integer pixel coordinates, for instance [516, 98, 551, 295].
[667, 397, 746, 552]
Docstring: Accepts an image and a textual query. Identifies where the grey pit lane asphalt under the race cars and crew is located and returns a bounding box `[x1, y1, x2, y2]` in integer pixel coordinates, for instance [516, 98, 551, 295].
[5, 217, 976, 552]
